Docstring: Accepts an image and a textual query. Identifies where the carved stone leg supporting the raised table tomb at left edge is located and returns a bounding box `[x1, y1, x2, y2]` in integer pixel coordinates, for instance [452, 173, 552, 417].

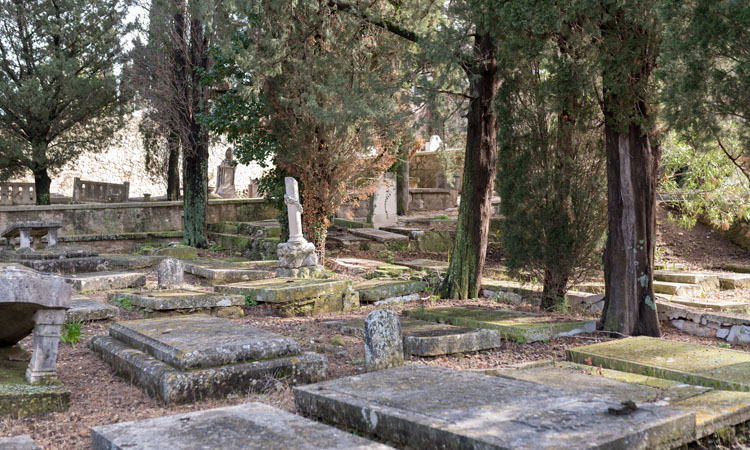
[26, 309, 65, 384]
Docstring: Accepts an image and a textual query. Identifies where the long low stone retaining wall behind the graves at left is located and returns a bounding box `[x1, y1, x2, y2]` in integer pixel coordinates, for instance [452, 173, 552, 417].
[0, 199, 277, 236]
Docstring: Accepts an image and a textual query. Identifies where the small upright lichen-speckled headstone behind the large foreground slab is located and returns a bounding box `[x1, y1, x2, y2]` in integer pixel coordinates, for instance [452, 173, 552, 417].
[364, 309, 404, 372]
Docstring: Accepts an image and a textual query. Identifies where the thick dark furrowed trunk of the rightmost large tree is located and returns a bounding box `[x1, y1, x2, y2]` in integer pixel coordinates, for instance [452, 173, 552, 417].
[602, 121, 660, 336]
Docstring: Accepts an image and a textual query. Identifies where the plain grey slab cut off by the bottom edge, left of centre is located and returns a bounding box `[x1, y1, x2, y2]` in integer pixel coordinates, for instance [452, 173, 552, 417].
[91, 403, 390, 450]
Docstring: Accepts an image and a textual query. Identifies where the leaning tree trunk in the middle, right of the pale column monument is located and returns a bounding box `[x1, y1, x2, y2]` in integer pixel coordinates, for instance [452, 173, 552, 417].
[440, 34, 499, 298]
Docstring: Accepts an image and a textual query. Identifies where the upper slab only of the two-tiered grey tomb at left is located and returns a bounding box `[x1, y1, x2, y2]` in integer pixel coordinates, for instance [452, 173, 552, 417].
[109, 314, 301, 370]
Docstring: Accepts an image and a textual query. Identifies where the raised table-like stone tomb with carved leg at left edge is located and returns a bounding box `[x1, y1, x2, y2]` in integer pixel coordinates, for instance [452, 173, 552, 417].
[0, 266, 71, 384]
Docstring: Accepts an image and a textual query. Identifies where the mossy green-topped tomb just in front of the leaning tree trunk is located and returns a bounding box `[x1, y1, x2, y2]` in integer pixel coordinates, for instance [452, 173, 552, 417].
[404, 308, 596, 342]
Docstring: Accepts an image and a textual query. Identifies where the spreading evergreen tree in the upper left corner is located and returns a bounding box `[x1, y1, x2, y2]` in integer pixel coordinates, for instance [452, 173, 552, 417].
[0, 0, 127, 204]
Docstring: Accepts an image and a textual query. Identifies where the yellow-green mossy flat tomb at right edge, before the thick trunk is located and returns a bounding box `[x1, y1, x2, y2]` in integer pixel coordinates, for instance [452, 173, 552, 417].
[565, 336, 750, 391]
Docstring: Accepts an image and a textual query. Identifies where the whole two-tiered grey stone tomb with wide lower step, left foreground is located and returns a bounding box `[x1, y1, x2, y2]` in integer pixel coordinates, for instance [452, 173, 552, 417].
[89, 314, 328, 404]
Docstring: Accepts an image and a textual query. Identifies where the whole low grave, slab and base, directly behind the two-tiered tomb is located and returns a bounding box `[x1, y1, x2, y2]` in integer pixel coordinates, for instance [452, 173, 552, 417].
[110, 289, 245, 317]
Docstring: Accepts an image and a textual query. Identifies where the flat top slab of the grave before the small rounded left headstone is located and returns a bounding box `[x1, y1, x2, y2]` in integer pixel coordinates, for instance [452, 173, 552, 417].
[111, 289, 245, 311]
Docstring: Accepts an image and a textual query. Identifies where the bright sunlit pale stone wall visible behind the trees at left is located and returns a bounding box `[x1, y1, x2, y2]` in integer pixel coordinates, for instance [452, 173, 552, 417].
[6, 112, 263, 197]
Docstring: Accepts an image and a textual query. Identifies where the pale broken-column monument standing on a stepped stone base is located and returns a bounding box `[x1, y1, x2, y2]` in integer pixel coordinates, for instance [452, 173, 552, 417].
[276, 177, 326, 278]
